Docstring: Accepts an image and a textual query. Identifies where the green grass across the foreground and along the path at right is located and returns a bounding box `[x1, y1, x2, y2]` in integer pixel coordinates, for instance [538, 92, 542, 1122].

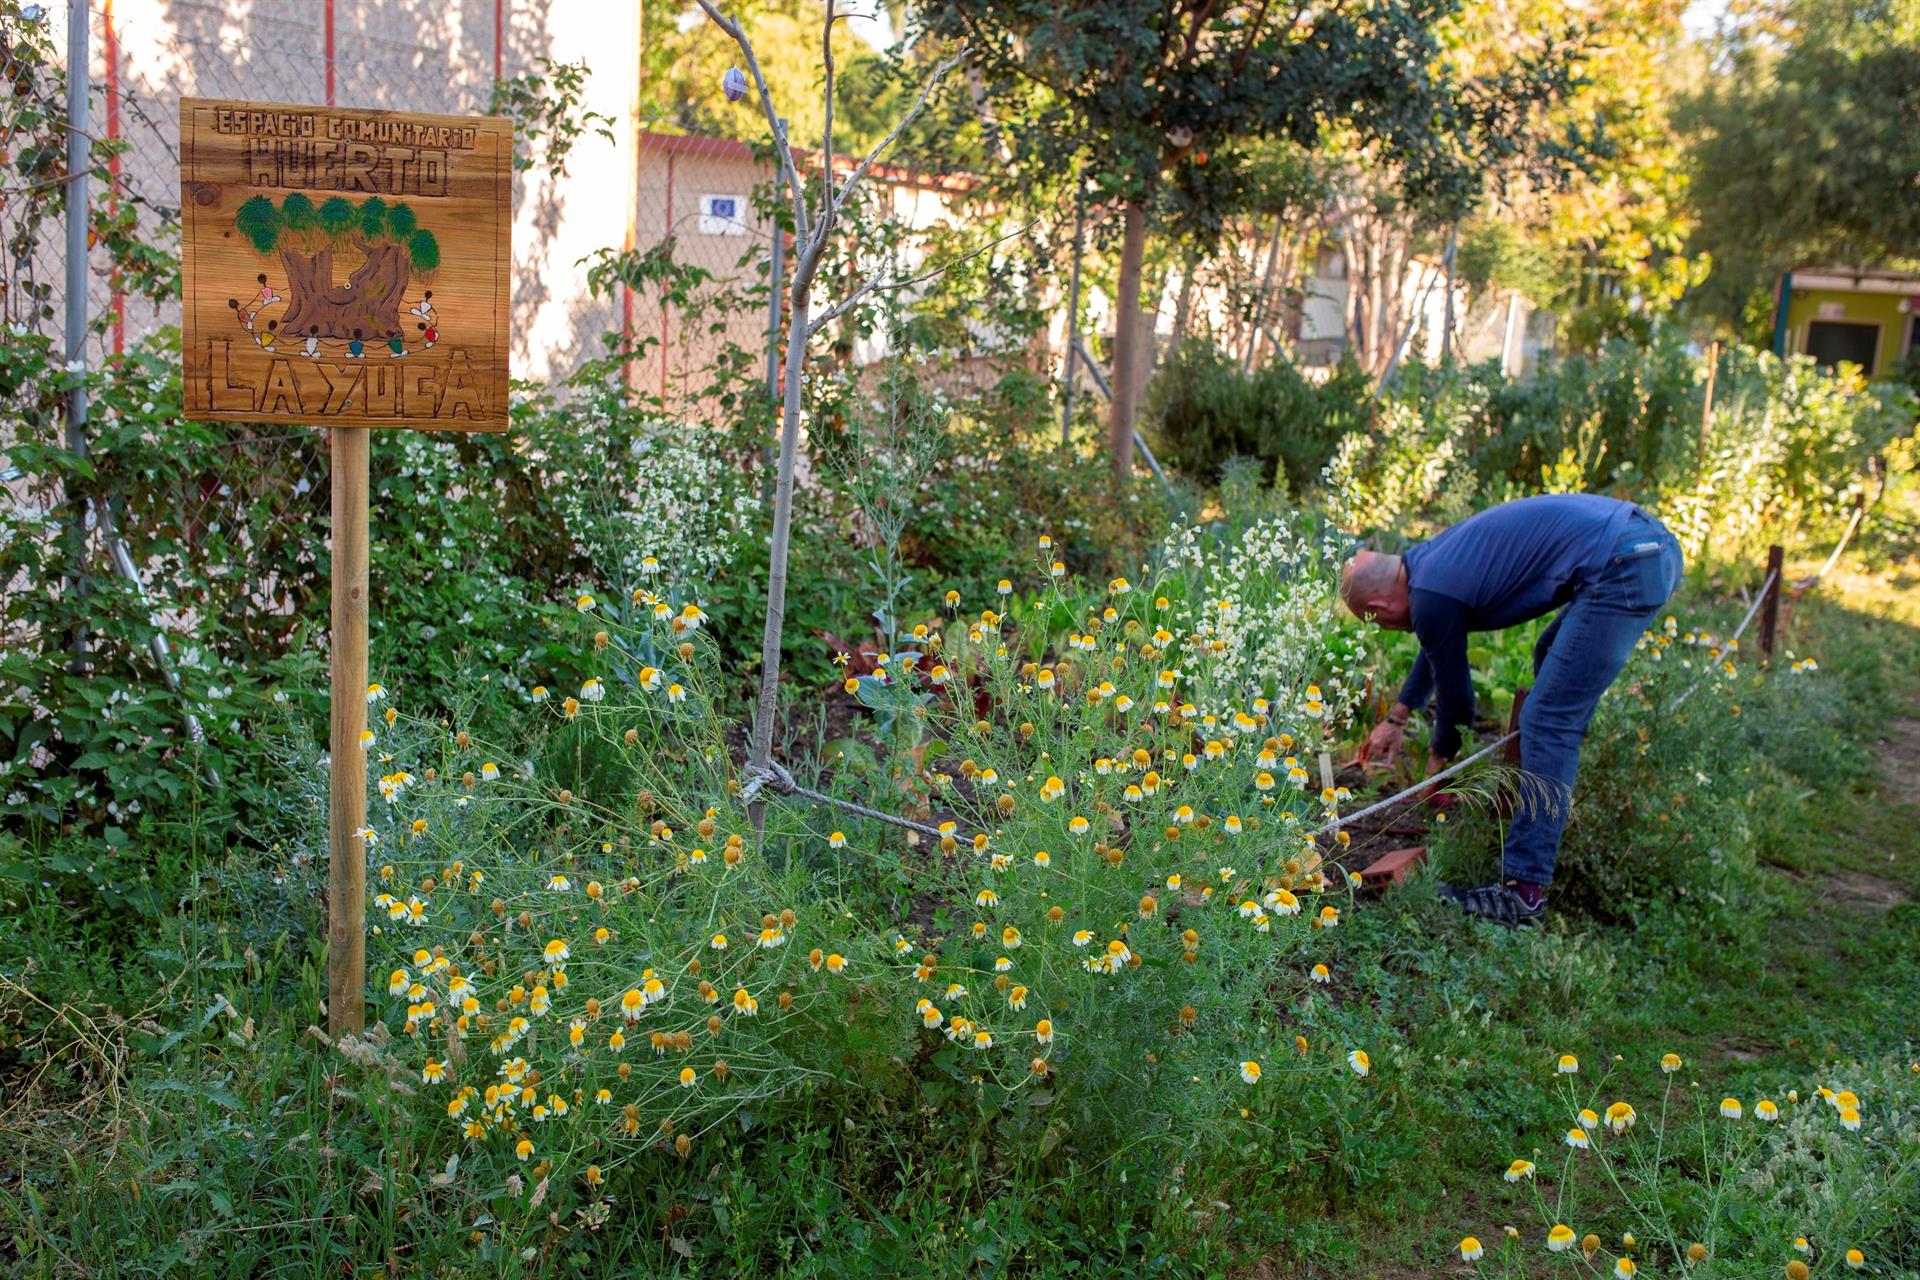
[0, 548, 1920, 1278]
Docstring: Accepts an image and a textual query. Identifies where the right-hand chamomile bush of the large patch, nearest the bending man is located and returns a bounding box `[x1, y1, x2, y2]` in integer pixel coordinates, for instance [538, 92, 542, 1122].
[847, 520, 1371, 1153]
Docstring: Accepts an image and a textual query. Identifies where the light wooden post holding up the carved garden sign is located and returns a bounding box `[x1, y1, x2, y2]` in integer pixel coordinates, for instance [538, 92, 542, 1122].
[326, 426, 369, 1040]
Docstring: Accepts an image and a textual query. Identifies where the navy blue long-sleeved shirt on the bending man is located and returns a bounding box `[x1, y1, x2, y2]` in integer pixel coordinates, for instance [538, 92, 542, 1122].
[1400, 493, 1636, 756]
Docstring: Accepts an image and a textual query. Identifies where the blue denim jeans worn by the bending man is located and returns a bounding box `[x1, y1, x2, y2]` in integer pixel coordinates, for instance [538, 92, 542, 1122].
[1501, 510, 1680, 885]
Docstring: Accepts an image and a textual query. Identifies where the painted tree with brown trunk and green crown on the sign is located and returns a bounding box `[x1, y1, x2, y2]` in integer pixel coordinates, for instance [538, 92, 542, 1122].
[234, 192, 440, 340]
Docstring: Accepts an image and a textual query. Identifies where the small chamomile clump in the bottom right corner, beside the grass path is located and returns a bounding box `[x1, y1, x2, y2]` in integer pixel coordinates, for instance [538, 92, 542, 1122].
[1455, 1054, 1920, 1280]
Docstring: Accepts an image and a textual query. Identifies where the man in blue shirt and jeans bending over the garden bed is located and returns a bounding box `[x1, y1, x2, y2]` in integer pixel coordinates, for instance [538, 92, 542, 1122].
[1340, 493, 1680, 925]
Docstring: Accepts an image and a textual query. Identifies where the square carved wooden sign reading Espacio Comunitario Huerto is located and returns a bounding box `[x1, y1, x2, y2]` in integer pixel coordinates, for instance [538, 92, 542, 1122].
[180, 98, 513, 432]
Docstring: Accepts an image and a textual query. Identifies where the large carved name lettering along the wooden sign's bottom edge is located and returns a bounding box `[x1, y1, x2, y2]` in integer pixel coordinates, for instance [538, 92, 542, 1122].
[186, 338, 488, 424]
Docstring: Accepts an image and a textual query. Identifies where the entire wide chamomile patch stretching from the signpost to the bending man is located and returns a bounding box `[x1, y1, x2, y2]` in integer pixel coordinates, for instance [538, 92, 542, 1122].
[311, 495, 1413, 1251]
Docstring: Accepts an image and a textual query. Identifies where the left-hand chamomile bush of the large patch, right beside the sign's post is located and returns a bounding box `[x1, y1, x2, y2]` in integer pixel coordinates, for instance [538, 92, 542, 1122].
[334, 587, 893, 1251]
